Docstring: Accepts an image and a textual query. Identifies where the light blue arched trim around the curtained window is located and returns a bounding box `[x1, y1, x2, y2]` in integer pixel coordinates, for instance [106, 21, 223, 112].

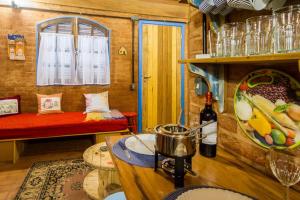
[35, 15, 111, 87]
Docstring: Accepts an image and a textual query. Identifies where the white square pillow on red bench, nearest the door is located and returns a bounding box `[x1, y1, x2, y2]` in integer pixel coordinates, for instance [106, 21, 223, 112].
[84, 91, 109, 113]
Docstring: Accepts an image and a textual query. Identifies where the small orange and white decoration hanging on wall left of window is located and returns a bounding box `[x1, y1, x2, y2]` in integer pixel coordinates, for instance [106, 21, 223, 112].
[7, 34, 25, 60]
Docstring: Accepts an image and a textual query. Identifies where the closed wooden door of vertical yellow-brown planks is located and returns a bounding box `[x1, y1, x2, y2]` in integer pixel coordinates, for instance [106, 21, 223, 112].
[139, 24, 182, 130]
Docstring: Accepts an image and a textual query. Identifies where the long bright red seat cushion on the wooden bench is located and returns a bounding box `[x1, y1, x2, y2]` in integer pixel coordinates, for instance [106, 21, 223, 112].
[0, 112, 127, 139]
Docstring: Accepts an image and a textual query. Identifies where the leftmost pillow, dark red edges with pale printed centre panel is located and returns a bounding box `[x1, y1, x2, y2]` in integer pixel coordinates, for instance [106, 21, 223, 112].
[0, 95, 21, 117]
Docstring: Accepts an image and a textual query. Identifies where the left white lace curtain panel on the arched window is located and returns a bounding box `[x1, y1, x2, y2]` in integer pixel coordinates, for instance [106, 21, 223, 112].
[37, 33, 75, 85]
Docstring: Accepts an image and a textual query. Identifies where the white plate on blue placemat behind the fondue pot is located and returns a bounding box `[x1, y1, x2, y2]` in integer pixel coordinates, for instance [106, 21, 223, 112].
[125, 134, 155, 155]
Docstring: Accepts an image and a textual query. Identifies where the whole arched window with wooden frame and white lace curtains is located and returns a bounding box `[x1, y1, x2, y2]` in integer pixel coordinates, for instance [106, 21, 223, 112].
[36, 16, 110, 86]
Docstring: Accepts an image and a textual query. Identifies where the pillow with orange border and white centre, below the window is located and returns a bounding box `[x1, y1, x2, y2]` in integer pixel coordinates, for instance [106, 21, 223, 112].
[37, 93, 63, 114]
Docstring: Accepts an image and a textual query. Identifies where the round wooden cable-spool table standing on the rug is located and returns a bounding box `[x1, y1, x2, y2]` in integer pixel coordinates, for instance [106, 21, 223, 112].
[83, 142, 121, 200]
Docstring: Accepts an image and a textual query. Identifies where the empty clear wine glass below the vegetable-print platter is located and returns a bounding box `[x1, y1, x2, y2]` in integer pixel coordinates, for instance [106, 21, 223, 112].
[268, 147, 300, 200]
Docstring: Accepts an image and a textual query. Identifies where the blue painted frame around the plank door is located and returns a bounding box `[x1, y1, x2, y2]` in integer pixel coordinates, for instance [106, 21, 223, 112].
[138, 20, 185, 132]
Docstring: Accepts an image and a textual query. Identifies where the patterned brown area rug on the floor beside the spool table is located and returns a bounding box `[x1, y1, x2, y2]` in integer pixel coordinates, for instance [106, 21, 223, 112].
[15, 159, 91, 200]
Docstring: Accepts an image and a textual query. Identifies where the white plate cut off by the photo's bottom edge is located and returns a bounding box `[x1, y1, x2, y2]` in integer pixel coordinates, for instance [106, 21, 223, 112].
[176, 188, 251, 200]
